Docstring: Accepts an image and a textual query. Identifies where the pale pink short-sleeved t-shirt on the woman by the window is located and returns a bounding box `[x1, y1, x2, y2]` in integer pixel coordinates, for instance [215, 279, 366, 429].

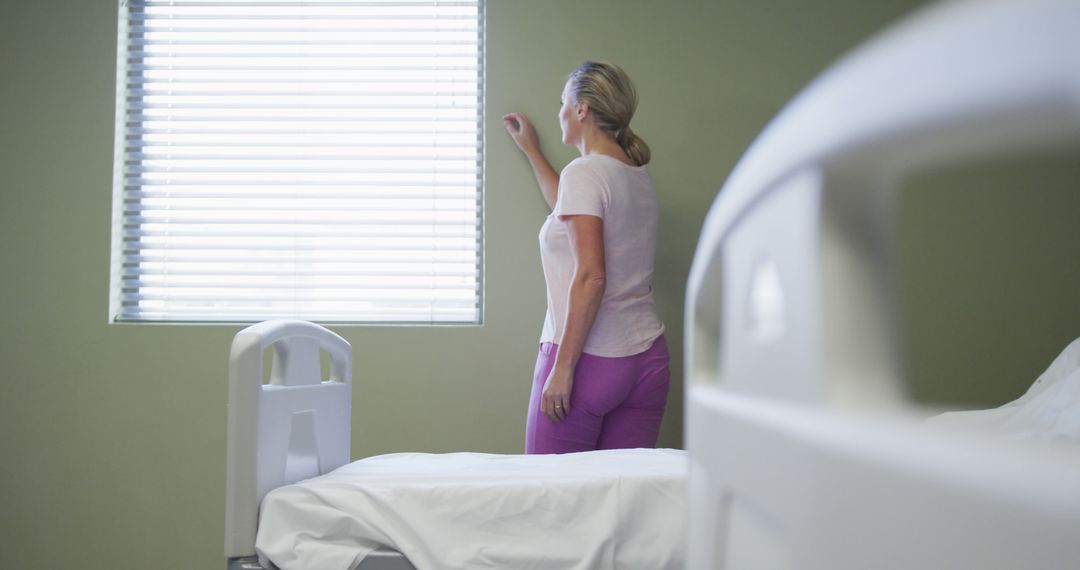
[540, 154, 664, 357]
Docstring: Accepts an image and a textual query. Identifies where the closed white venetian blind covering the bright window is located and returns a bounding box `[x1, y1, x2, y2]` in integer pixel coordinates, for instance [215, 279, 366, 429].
[110, 0, 483, 323]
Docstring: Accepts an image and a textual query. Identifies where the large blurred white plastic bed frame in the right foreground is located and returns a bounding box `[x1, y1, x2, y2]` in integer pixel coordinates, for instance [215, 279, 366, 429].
[686, 0, 1080, 570]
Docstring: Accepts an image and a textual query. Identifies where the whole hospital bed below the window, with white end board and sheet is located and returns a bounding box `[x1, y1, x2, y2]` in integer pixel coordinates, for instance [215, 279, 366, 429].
[226, 321, 687, 570]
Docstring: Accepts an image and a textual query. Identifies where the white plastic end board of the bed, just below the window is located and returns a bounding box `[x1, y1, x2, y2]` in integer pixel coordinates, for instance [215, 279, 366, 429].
[225, 321, 352, 558]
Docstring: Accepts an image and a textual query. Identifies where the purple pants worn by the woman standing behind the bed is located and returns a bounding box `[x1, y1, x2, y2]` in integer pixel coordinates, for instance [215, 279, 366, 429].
[525, 336, 671, 453]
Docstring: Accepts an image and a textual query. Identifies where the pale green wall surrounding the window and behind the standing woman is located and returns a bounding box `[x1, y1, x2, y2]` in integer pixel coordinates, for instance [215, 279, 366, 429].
[10, 0, 1078, 569]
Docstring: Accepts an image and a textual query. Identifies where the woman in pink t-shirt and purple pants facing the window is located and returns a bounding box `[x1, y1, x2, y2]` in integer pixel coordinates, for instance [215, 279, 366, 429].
[503, 62, 670, 453]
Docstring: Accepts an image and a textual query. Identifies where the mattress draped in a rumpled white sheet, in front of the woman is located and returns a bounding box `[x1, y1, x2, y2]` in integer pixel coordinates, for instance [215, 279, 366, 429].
[256, 449, 688, 570]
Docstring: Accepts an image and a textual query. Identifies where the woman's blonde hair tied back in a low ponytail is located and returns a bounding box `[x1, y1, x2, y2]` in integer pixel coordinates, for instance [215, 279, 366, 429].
[567, 62, 651, 166]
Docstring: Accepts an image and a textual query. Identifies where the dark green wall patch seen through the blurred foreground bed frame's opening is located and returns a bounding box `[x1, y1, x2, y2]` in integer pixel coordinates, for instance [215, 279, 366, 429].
[896, 149, 1080, 409]
